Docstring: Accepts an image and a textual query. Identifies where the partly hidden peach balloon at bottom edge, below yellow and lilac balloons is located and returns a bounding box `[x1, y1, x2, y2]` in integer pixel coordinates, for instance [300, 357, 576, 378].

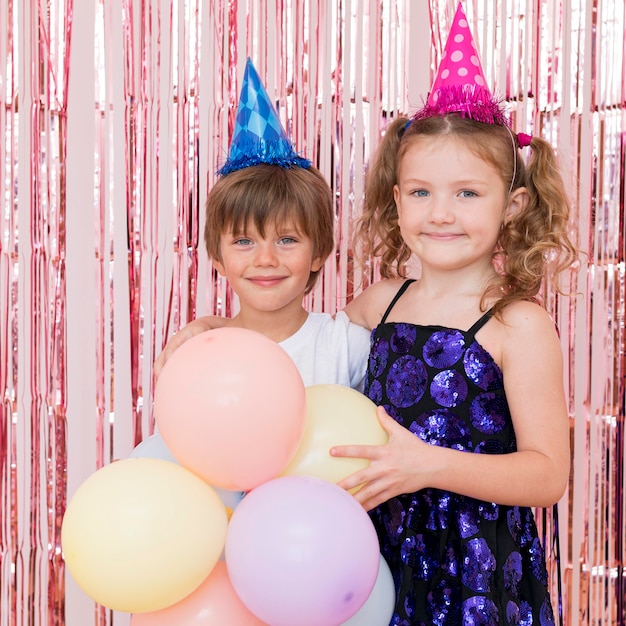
[130, 561, 266, 626]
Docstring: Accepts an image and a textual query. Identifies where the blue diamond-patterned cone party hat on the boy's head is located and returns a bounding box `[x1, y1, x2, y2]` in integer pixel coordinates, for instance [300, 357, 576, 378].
[217, 58, 311, 176]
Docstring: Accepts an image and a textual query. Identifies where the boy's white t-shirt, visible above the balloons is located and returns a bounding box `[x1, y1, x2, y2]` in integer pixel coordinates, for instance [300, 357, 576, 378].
[278, 311, 370, 391]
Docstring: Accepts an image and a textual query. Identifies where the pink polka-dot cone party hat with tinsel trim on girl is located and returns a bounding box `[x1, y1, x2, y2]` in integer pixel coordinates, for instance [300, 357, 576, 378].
[414, 3, 509, 126]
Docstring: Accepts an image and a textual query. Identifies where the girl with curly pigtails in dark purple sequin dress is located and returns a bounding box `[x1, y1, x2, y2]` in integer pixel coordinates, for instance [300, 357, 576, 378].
[331, 4, 575, 626]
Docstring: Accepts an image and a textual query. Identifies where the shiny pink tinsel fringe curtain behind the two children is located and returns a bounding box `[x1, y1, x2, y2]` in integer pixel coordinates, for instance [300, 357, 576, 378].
[0, 0, 626, 626]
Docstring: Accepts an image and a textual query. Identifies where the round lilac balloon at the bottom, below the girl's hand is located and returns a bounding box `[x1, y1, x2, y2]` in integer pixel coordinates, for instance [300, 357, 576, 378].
[225, 476, 380, 626]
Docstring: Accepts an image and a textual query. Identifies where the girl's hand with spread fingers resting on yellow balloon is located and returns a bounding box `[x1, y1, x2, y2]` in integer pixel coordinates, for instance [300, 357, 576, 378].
[330, 406, 426, 511]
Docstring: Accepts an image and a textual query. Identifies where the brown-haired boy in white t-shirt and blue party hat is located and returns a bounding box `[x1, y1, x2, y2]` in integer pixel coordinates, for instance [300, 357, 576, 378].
[154, 59, 369, 390]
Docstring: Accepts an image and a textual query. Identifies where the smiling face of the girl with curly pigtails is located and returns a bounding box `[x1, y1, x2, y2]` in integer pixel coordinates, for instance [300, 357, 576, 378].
[394, 137, 508, 271]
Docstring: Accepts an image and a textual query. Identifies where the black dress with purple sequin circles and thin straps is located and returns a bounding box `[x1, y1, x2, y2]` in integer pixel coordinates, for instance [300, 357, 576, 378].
[365, 281, 554, 626]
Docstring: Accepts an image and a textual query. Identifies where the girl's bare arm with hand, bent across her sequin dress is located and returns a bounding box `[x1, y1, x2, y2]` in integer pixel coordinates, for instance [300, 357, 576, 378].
[331, 303, 570, 510]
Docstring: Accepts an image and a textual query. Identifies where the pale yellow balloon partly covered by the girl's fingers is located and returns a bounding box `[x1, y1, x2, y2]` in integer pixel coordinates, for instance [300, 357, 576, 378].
[283, 385, 388, 483]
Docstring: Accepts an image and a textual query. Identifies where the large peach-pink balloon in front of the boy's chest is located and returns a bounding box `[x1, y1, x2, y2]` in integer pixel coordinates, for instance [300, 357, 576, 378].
[154, 327, 305, 491]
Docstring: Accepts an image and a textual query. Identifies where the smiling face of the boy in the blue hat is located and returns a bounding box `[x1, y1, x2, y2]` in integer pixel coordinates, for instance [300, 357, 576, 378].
[213, 223, 322, 312]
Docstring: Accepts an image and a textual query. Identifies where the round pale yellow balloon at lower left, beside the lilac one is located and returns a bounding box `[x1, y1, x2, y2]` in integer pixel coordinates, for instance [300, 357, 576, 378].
[61, 458, 228, 612]
